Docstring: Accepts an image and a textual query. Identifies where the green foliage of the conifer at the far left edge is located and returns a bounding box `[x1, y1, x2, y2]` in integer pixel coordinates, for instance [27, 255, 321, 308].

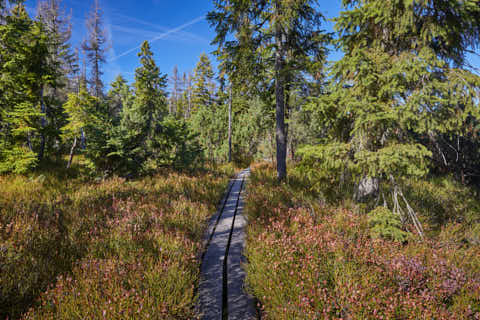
[0, 4, 56, 172]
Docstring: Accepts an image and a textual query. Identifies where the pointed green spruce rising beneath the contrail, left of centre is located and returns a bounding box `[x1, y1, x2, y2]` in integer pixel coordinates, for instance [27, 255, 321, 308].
[108, 41, 168, 174]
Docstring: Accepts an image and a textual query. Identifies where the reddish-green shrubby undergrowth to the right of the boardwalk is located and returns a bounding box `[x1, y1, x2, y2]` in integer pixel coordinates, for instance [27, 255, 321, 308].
[246, 164, 480, 320]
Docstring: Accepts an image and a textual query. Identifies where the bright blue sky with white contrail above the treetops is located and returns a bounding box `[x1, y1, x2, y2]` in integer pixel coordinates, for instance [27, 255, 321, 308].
[25, 0, 480, 87]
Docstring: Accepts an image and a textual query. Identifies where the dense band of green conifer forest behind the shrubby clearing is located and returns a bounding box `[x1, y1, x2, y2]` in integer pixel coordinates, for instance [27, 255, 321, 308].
[0, 1, 479, 188]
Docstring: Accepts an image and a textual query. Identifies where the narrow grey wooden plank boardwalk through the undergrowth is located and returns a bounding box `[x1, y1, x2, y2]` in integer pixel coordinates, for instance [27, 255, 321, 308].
[198, 169, 256, 320]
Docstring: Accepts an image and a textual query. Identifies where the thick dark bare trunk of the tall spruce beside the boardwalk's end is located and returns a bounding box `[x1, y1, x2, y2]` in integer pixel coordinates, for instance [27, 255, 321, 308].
[275, 13, 287, 181]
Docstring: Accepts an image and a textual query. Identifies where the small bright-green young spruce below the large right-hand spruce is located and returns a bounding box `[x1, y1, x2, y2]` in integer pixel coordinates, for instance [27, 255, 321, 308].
[368, 207, 408, 242]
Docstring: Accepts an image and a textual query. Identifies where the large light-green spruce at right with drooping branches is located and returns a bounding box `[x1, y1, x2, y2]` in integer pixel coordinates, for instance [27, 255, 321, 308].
[303, 0, 480, 234]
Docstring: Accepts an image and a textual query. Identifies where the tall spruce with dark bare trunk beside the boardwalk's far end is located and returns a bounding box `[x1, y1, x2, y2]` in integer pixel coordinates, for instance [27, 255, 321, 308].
[208, 0, 328, 181]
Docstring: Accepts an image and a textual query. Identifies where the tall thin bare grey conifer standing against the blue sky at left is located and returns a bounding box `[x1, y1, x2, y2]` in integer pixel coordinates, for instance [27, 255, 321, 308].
[82, 0, 109, 98]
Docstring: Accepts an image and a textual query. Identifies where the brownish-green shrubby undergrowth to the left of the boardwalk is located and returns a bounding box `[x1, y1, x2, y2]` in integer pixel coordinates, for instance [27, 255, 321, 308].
[0, 161, 232, 319]
